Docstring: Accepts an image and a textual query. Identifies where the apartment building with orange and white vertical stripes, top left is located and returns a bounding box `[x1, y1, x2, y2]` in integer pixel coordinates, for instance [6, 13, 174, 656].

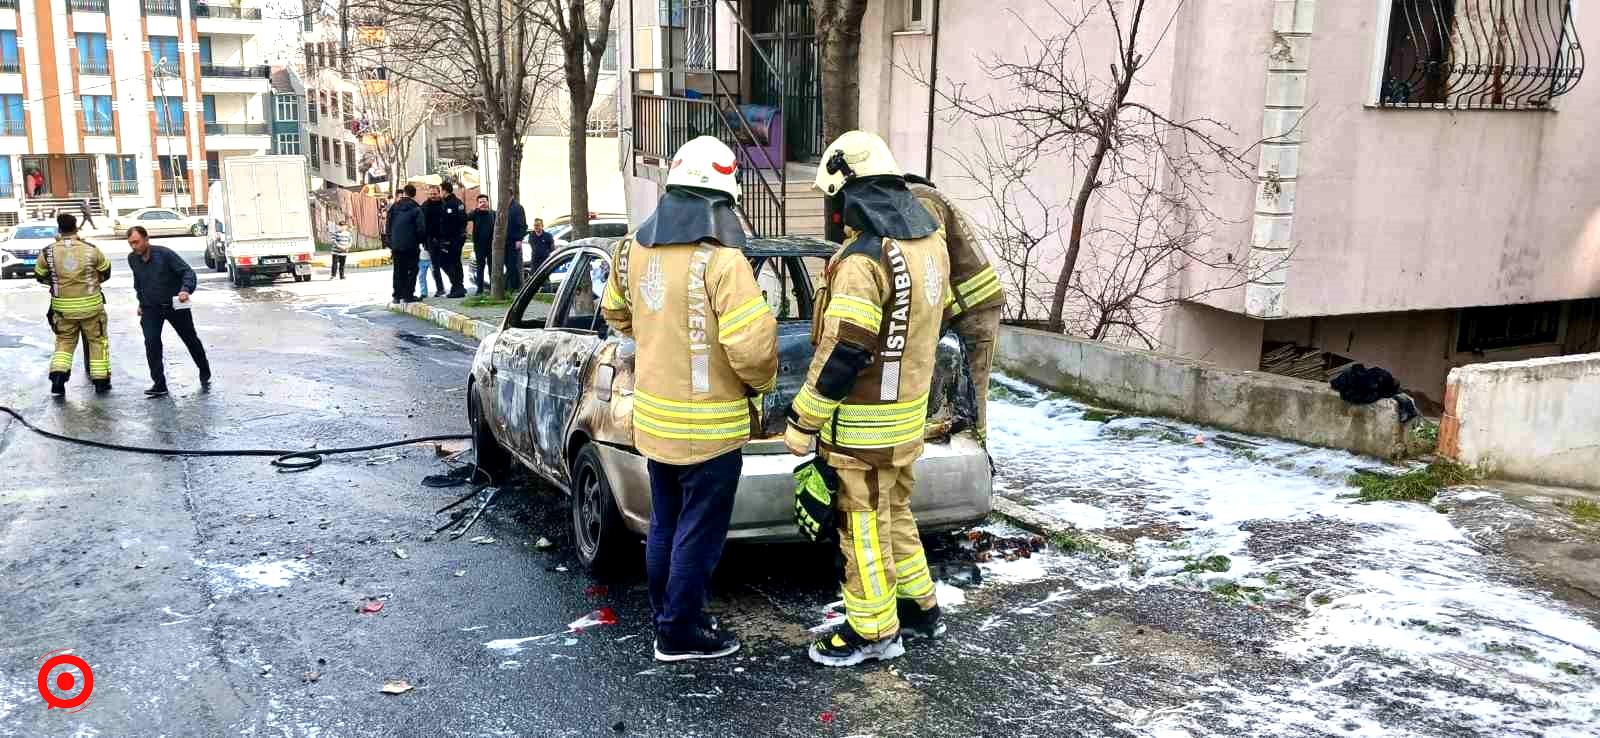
[0, 0, 300, 219]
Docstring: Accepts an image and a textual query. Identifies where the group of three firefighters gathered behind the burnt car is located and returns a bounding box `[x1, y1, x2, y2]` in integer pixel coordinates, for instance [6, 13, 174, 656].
[602, 131, 1005, 666]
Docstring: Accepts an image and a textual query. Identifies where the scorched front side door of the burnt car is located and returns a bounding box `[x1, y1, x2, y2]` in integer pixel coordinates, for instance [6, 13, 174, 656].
[490, 255, 578, 469]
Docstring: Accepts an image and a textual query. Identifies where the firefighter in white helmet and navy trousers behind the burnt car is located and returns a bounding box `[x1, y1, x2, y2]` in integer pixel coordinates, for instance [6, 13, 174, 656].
[600, 136, 778, 661]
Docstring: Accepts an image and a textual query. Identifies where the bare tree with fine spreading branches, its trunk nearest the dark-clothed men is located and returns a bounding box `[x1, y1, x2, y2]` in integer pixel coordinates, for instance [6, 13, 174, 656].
[342, 0, 555, 299]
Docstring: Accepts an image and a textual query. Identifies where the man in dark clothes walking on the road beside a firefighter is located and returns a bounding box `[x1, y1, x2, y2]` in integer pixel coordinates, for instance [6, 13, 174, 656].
[128, 226, 211, 397]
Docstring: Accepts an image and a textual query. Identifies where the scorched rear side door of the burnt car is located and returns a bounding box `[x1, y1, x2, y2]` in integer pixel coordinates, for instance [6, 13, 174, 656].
[533, 248, 611, 480]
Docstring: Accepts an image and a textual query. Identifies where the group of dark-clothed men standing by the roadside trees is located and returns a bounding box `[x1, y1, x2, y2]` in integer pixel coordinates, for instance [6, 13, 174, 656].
[386, 182, 552, 303]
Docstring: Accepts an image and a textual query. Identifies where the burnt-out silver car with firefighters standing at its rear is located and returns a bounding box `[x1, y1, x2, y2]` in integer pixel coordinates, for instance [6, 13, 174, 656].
[467, 237, 992, 570]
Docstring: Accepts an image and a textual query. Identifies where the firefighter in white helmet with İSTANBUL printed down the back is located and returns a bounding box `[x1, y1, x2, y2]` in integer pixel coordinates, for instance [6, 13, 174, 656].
[784, 131, 950, 666]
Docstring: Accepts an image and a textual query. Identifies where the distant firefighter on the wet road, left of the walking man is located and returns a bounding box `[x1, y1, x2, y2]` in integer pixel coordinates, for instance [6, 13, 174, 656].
[34, 213, 110, 395]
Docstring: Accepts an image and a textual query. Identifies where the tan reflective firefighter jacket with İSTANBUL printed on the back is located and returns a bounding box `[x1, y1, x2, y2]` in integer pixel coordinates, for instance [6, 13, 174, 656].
[789, 229, 950, 464]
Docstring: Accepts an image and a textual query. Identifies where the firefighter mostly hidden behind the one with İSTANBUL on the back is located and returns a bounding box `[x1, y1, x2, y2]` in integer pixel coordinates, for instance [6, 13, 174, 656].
[906, 174, 1005, 447]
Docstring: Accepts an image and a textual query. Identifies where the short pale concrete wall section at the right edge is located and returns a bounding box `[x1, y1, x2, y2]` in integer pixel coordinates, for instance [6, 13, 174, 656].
[1438, 354, 1600, 488]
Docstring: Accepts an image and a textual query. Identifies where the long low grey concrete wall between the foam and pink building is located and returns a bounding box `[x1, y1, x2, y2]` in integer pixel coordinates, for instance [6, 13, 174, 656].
[995, 327, 1405, 458]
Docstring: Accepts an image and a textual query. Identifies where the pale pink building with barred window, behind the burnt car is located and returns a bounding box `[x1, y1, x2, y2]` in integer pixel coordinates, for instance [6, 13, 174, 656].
[619, 0, 1600, 400]
